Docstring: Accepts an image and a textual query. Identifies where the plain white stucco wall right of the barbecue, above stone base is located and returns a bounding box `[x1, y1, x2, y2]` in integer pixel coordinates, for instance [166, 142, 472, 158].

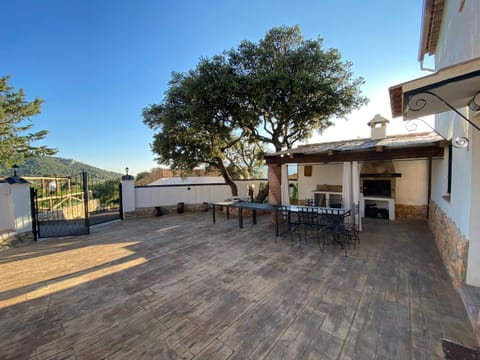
[393, 160, 428, 205]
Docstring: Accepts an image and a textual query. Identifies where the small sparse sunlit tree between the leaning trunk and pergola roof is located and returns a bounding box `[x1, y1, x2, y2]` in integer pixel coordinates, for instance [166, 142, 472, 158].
[225, 137, 265, 179]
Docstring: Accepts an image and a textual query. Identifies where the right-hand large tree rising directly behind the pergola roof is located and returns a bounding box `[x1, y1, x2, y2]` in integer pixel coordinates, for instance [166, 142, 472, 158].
[227, 26, 367, 151]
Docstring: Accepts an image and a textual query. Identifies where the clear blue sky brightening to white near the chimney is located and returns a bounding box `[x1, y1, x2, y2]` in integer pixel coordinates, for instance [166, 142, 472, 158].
[0, 0, 427, 174]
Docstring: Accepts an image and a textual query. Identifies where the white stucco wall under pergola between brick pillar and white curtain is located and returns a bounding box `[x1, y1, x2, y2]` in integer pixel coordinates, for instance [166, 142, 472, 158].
[298, 163, 343, 200]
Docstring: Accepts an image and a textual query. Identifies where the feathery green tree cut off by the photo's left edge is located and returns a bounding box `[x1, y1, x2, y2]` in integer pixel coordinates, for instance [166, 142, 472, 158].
[0, 76, 57, 172]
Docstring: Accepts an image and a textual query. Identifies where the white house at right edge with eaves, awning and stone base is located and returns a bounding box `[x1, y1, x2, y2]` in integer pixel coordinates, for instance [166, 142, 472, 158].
[390, 0, 480, 340]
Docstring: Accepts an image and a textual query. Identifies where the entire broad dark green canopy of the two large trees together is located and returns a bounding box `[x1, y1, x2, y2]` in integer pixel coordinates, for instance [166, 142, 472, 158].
[143, 26, 367, 195]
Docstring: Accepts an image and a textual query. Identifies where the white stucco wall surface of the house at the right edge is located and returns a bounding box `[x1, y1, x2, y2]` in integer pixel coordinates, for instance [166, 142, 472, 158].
[432, 0, 480, 286]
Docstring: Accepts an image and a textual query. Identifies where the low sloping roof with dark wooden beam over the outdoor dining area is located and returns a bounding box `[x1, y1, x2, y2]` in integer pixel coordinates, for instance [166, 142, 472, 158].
[264, 132, 445, 164]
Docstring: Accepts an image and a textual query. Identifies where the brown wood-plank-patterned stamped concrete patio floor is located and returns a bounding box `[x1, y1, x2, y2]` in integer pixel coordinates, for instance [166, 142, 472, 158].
[0, 213, 476, 359]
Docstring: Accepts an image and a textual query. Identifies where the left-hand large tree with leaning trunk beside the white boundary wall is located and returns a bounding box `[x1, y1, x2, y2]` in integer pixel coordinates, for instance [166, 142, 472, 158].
[143, 56, 249, 196]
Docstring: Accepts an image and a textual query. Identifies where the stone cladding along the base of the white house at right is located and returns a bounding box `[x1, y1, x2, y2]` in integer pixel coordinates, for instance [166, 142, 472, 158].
[429, 201, 468, 288]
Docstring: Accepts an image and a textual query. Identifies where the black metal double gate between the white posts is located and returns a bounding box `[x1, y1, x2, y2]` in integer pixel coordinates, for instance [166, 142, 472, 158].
[31, 172, 122, 238]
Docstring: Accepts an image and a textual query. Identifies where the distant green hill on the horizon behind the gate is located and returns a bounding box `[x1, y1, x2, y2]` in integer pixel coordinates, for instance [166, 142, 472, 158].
[0, 156, 122, 178]
